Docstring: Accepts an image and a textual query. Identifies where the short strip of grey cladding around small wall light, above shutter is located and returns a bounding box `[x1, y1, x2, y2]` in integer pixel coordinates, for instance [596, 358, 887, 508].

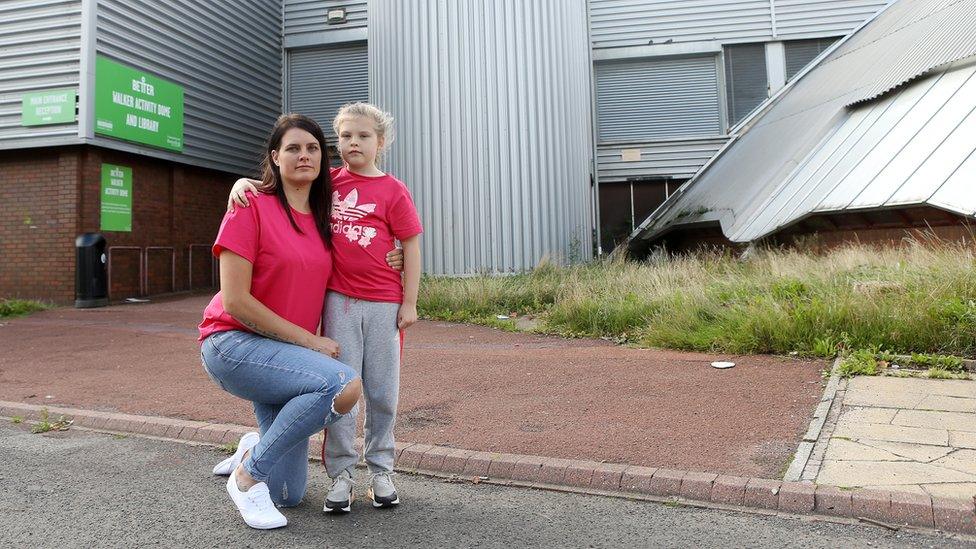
[282, 0, 372, 48]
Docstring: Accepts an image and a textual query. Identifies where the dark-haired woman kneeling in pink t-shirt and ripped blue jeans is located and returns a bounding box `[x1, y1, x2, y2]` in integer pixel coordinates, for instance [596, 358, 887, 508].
[200, 114, 362, 529]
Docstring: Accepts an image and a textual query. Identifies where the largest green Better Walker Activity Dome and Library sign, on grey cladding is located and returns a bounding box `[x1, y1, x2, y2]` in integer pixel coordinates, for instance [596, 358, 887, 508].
[95, 56, 183, 151]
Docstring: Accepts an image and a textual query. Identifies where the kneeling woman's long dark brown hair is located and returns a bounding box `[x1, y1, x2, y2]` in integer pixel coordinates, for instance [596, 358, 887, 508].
[260, 114, 332, 246]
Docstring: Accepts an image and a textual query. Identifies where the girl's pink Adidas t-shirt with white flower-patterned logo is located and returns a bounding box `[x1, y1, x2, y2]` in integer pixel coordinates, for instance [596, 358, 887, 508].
[329, 167, 424, 303]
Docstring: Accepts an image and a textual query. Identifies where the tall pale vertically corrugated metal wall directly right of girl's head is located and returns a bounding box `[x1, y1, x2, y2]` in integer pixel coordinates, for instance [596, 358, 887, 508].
[369, 0, 592, 274]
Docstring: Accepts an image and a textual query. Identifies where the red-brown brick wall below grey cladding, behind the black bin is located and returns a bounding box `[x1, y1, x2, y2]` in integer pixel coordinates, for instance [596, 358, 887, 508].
[0, 147, 237, 304]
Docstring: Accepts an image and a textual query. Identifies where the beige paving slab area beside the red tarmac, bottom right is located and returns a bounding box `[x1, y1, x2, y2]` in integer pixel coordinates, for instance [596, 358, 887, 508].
[813, 376, 976, 501]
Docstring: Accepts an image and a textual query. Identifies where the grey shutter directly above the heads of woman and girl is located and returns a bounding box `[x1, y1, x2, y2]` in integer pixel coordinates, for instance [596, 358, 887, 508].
[287, 43, 369, 134]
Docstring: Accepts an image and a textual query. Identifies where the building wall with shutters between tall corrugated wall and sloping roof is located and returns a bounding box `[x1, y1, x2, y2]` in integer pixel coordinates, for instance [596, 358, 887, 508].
[589, 0, 887, 251]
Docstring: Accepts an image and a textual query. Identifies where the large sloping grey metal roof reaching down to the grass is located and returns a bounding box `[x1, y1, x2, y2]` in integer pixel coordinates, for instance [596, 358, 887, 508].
[632, 0, 976, 242]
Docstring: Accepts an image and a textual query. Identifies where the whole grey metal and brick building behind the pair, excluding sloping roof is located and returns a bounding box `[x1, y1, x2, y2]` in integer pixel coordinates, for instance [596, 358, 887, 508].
[0, 0, 885, 302]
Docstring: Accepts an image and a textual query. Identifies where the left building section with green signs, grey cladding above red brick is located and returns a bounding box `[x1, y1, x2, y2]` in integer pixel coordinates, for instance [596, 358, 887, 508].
[0, 0, 282, 303]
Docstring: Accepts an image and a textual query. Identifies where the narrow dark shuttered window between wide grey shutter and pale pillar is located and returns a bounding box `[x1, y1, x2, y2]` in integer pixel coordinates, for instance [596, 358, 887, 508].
[725, 44, 769, 126]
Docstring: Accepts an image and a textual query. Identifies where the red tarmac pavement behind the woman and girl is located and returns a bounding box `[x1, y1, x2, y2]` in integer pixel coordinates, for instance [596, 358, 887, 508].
[0, 296, 826, 478]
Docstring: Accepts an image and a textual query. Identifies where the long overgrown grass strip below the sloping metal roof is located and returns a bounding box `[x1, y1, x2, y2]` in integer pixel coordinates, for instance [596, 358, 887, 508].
[419, 244, 976, 357]
